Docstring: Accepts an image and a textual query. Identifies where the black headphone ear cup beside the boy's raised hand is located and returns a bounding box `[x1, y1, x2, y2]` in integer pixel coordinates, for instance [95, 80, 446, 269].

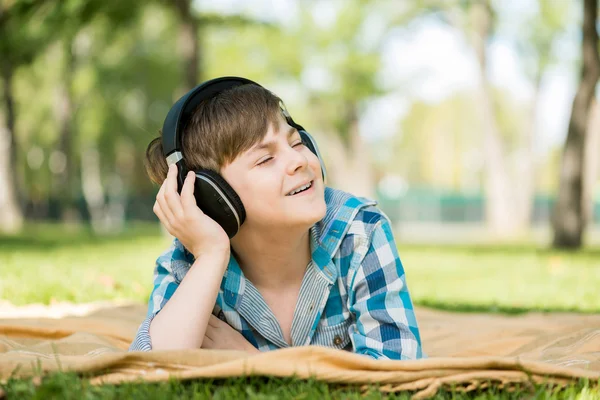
[194, 169, 246, 239]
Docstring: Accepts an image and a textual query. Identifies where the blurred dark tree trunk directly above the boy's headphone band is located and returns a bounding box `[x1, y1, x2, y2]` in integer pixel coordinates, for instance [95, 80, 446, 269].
[174, 0, 202, 95]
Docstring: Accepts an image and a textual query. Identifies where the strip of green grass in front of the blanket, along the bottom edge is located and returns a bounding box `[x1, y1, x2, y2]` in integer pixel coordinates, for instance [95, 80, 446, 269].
[0, 373, 600, 400]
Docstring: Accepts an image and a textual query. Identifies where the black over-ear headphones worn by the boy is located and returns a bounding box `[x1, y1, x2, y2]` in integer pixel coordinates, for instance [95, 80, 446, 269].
[162, 76, 327, 239]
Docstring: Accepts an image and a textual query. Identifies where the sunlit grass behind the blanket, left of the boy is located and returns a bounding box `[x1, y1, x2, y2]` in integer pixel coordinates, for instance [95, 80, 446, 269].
[0, 224, 170, 305]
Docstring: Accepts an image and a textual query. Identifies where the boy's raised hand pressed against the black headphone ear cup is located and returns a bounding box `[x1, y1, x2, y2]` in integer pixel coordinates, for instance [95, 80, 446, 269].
[152, 164, 230, 258]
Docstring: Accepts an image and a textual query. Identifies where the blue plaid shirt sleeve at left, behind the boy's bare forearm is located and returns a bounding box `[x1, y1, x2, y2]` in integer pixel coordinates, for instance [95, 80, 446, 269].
[129, 239, 193, 351]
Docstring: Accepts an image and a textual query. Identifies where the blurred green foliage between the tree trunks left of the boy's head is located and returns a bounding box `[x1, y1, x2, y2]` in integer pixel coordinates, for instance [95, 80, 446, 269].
[14, 1, 181, 203]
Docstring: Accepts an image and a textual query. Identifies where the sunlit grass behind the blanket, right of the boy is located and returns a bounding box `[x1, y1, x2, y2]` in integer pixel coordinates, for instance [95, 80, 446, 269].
[399, 242, 600, 313]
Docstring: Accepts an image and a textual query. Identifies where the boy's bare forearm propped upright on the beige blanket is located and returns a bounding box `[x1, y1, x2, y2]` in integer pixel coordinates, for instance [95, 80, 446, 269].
[150, 254, 229, 350]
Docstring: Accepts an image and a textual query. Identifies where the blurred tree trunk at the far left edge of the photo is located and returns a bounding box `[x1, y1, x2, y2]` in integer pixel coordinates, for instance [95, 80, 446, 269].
[0, 59, 23, 233]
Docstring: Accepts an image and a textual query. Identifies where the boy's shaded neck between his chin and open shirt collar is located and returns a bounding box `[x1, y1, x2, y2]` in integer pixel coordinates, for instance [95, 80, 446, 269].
[231, 225, 311, 290]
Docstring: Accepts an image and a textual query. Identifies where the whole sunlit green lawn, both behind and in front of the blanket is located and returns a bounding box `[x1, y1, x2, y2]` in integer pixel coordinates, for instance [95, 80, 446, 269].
[0, 224, 600, 399]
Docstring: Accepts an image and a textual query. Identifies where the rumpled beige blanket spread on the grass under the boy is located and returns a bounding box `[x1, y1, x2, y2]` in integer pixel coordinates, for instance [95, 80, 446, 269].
[0, 305, 600, 398]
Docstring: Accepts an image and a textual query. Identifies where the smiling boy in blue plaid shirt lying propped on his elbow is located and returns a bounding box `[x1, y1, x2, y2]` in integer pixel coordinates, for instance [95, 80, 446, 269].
[130, 78, 423, 359]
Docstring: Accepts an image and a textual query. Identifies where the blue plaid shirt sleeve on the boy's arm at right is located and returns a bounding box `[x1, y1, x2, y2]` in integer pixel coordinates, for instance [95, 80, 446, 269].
[348, 217, 425, 360]
